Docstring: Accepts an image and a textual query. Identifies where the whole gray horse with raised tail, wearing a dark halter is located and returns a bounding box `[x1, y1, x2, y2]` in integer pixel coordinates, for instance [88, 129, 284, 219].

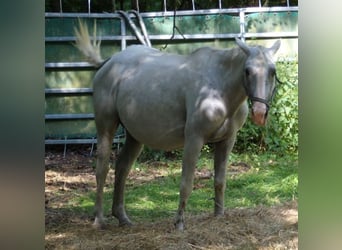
[75, 22, 280, 230]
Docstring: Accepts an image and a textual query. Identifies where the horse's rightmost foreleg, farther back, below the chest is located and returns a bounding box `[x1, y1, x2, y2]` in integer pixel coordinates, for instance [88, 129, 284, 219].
[214, 137, 235, 216]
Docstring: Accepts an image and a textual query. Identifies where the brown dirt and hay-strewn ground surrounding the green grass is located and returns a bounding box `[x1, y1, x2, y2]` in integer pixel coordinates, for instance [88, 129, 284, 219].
[45, 147, 298, 249]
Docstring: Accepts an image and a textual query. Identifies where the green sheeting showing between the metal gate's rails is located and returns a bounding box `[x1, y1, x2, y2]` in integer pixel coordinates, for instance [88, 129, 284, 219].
[45, 11, 298, 142]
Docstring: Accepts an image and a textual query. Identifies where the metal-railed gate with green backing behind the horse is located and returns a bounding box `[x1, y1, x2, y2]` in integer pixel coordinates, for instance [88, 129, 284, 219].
[45, 1, 298, 149]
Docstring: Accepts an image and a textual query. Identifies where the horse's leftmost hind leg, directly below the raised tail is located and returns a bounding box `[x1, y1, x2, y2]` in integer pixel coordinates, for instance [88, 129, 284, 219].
[93, 116, 118, 228]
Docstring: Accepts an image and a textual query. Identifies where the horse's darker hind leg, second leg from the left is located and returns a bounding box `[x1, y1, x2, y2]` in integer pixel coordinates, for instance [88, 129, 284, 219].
[112, 132, 142, 226]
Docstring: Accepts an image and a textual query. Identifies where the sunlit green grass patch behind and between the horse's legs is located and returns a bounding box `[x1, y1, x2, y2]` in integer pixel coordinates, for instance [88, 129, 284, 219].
[69, 151, 298, 221]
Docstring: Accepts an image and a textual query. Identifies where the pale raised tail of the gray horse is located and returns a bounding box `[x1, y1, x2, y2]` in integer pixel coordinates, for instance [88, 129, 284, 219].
[74, 20, 104, 67]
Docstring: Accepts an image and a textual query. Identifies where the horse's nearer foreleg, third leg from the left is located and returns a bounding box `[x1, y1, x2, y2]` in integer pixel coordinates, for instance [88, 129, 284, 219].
[175, 138, 203, 230]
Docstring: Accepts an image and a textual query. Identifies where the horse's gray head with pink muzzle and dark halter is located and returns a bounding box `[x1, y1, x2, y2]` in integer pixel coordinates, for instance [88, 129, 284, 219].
[235, 38, 280, 126]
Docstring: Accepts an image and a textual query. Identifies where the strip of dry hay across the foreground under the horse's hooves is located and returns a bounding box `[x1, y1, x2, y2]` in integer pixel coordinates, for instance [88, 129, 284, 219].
[45, 202, 298, 249]
